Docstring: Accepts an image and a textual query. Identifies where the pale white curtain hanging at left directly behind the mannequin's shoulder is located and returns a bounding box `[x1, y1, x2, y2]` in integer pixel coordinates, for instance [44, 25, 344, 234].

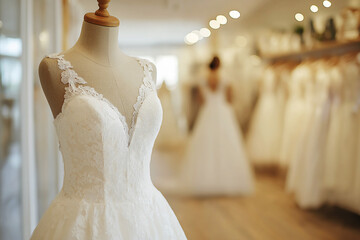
[32, 0, 63, 234]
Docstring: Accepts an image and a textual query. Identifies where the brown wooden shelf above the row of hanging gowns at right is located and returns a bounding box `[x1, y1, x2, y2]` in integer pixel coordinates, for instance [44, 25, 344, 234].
[262, 38, 360, 63]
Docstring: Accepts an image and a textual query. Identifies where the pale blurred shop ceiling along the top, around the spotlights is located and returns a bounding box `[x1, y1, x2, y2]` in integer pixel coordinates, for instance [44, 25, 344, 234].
[77, 0, 352, 46]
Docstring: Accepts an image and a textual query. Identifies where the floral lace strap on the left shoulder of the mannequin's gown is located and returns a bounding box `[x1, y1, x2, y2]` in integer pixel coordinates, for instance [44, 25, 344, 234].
[47, 54, 86, 96]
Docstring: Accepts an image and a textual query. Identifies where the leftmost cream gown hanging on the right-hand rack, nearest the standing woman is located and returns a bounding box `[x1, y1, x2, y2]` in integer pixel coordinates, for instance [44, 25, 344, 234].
[246, 68, 283, 165]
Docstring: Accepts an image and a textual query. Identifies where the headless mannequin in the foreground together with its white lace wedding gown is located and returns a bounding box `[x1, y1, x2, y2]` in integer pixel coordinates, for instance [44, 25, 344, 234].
[31, 0, 186, 240]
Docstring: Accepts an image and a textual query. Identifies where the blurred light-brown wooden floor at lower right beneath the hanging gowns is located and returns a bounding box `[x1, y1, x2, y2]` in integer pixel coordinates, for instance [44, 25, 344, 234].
[166, 175, 360, 240]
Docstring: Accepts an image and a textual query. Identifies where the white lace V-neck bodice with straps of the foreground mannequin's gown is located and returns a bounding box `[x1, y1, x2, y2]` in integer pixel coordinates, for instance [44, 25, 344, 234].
[48, 54, 162, 202]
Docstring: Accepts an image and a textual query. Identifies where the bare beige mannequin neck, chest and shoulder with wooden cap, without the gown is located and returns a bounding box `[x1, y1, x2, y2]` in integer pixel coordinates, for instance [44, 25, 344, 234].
[39, 0, 156, 124]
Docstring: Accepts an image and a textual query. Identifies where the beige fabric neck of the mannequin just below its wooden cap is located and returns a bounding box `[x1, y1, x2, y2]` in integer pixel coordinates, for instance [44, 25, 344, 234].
[73, 21, 121, 66]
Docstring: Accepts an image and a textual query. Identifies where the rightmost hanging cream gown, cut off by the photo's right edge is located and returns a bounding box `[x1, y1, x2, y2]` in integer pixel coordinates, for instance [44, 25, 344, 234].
[329, 59, 360, 213]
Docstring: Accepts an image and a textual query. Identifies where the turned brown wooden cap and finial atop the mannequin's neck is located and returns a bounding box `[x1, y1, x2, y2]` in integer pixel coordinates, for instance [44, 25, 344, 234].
[84, 0, 120, 27]
